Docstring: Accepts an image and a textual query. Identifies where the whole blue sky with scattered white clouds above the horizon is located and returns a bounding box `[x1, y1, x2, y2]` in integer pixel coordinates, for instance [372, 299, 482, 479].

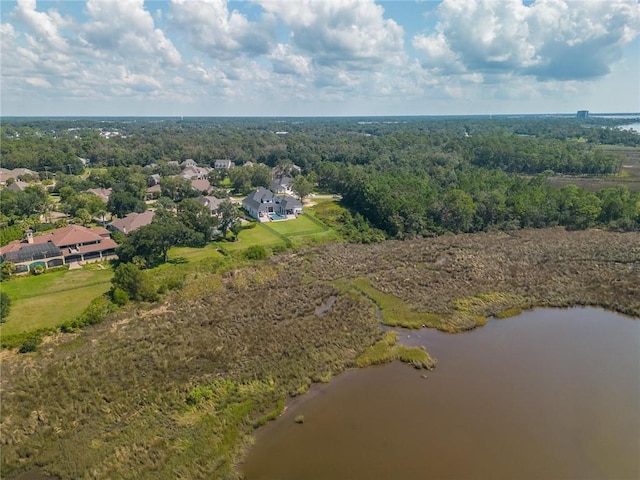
[0, 0, 640, 116]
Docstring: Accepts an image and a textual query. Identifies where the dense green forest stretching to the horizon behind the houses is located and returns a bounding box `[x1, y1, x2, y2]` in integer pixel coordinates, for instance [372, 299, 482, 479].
[0, 116, 640, 238]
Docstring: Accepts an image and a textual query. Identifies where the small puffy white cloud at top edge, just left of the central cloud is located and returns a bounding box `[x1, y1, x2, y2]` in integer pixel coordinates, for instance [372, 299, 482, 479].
[170, 0, 273, 59]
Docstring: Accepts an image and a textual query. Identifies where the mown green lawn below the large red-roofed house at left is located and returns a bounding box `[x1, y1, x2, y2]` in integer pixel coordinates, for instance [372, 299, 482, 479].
[0, 268, 113, 335]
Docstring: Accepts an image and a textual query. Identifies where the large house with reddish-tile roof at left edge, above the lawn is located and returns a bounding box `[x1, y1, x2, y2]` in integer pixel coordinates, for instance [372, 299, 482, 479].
[0, 225, 118, 273]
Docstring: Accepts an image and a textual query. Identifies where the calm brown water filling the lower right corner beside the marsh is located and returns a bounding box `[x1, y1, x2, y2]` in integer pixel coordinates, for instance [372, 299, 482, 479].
[240, 308, 640, 480]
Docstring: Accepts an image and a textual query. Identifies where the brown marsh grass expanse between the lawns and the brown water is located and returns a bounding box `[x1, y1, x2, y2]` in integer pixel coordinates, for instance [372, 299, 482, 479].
[0, 228, 640, 480]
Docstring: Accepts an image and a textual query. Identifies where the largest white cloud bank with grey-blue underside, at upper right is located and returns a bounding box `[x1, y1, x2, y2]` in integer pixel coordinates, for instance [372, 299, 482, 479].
[412, 0, 640, 80]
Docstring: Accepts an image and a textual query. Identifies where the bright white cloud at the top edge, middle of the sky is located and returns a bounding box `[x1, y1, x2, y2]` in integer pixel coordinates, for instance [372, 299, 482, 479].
[258, 0, 404, 69]
